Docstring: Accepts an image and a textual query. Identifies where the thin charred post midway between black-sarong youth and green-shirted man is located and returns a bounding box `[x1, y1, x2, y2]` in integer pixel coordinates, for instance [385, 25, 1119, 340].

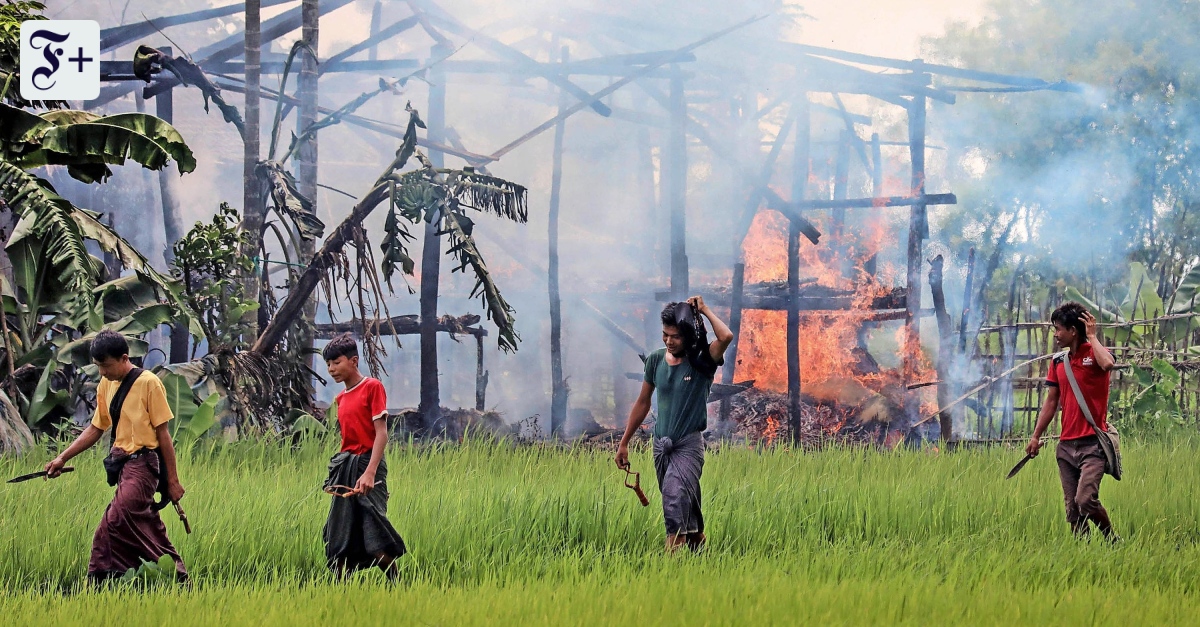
[546, 46, 570, 437]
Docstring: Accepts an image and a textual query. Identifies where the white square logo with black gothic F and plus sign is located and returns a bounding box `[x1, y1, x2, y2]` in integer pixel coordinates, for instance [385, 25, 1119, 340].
[20, 19, 100, 100]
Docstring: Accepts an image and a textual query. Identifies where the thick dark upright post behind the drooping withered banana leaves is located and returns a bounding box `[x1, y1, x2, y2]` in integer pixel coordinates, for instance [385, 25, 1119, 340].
[418, 44, 449, 431]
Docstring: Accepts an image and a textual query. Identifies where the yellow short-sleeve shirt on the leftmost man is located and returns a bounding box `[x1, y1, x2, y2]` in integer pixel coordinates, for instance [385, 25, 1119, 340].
[91, 370, 175, 454]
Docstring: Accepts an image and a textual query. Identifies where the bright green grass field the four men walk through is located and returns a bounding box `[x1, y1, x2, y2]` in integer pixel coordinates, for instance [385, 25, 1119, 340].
[0, 441, 1200, 626]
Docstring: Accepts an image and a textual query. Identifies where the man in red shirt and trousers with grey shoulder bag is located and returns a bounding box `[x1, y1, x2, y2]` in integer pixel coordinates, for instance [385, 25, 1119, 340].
[1025, 303, 1117, 539]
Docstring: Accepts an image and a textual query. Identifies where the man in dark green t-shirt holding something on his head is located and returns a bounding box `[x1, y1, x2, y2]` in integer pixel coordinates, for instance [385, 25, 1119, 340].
[616, 297, 733, 551]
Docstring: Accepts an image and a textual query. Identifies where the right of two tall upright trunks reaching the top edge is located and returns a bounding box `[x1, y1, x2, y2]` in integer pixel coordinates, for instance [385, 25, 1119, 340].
[293, 0, 320, 369]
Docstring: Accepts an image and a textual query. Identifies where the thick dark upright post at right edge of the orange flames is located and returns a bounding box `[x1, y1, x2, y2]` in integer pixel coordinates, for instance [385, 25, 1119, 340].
[904, 81, 928, 420]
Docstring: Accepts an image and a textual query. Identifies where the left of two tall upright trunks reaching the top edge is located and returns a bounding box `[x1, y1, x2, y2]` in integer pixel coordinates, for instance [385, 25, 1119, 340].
[241, 0, 266, 340]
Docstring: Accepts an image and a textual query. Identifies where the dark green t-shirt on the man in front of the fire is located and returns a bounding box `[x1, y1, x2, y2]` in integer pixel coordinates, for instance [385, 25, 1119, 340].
[643, 348, 725, 442]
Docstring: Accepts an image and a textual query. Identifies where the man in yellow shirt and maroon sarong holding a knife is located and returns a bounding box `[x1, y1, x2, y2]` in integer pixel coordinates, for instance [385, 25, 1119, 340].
[46, 330, 187, 581]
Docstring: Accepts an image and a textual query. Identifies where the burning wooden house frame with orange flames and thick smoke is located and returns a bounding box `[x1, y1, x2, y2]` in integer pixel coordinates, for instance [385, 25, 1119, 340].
[82, 0, 1075, 446]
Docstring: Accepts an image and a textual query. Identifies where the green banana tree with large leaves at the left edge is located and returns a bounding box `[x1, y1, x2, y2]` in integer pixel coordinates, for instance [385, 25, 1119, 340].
[0, 103, 200, 428]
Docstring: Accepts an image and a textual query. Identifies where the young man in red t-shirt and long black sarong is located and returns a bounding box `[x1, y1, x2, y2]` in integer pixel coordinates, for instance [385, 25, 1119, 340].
[322, 333, 407, 579]
